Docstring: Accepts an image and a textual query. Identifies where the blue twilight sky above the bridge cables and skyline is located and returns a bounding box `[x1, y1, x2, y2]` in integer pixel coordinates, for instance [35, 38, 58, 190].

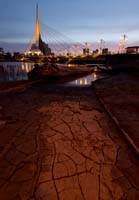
[0, 0, 139, 51]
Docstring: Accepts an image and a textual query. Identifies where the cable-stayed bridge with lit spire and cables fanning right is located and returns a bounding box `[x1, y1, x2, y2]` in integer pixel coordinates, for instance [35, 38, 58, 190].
[25, 5, 85, 56]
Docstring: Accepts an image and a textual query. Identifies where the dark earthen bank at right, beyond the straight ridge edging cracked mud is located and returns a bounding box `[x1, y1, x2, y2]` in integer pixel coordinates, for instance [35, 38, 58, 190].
[93, 73, 139, 154]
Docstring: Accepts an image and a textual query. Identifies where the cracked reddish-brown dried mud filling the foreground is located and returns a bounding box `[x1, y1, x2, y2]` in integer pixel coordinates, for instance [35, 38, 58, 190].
[0, 79, 139, 200]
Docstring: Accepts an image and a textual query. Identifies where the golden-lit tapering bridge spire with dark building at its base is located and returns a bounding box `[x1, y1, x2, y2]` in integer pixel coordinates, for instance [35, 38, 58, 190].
[27, 4, 51, 55]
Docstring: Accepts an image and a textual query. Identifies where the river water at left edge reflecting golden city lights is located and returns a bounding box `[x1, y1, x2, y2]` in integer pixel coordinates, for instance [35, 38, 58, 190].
[0, 62, 33, 81]
